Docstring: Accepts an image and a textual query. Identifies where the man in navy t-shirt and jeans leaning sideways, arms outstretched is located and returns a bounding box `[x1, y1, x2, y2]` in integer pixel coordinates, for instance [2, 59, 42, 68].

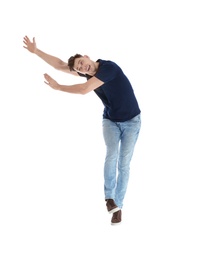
[23, 36, 141, 225]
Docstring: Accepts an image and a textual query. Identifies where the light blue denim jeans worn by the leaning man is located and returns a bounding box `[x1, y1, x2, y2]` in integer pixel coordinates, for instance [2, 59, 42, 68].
[103, 114, 141, 208]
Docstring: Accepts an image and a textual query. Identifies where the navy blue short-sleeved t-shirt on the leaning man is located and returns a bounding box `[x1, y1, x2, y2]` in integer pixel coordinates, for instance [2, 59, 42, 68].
[79, 59, 140, 122]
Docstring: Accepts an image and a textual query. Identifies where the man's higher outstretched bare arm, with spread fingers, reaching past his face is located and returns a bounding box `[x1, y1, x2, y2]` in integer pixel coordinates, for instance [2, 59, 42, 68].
[23, 36, 79, 76]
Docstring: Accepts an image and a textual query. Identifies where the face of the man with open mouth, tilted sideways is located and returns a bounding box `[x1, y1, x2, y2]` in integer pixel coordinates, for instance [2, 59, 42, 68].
[73, 55, 96, 76]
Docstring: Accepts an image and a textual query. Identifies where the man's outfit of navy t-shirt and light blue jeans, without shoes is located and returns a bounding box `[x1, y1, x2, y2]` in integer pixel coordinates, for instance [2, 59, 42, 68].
[79, 59, 141, 208]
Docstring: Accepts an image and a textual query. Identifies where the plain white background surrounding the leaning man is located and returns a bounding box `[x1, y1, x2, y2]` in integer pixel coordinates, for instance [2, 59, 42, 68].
[0, 0, 199, 260]
